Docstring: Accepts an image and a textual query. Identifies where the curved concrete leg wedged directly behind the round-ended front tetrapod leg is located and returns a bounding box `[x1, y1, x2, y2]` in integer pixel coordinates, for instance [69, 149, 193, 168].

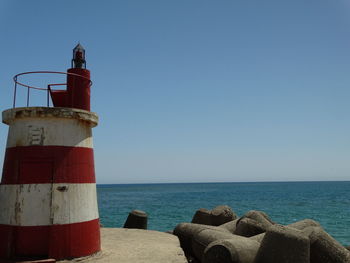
[192, 228, 237, 260]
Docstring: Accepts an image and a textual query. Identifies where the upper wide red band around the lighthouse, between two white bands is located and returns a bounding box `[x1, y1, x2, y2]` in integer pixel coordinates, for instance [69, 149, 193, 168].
[1, 146, 95, 184]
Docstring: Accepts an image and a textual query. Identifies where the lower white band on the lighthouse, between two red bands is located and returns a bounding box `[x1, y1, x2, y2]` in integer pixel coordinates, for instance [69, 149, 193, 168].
[0, 184, 99, 226]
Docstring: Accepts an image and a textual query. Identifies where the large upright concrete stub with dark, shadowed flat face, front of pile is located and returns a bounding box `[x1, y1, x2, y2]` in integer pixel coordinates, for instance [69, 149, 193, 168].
[254, 225, 310, 263]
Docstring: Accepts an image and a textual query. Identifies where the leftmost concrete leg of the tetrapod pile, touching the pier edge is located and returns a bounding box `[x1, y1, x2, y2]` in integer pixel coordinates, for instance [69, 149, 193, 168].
[173, 223, 229, 255]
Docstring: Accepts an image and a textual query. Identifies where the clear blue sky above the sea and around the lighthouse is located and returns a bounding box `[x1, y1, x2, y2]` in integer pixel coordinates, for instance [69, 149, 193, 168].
[0, 0, 350, 183]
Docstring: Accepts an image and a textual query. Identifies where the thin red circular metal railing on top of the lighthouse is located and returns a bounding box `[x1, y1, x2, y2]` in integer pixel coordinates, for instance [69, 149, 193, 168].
[13, 71, 92, 108]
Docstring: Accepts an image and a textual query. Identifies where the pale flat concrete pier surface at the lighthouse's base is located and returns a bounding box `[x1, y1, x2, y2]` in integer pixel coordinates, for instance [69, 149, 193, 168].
[57, 228, 187, 263]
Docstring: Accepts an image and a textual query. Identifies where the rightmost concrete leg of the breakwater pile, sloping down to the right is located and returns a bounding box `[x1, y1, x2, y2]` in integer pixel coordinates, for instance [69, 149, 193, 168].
[303, 226, 350, 263]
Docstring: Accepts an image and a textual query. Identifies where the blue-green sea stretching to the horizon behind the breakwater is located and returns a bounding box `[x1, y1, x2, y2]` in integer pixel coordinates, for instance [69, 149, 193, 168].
[97, 181, 350, 245]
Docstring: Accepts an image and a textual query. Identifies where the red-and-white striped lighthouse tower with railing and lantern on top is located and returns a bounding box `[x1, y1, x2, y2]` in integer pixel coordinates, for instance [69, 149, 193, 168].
[0, 44, 100, 259]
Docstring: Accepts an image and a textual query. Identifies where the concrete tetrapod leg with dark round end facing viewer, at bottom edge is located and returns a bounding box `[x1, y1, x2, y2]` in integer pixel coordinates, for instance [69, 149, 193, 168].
[202, 235, 260, 263]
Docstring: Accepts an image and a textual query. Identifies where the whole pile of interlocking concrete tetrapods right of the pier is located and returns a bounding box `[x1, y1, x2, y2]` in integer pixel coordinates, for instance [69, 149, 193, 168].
[174, 206, 350, 263]
